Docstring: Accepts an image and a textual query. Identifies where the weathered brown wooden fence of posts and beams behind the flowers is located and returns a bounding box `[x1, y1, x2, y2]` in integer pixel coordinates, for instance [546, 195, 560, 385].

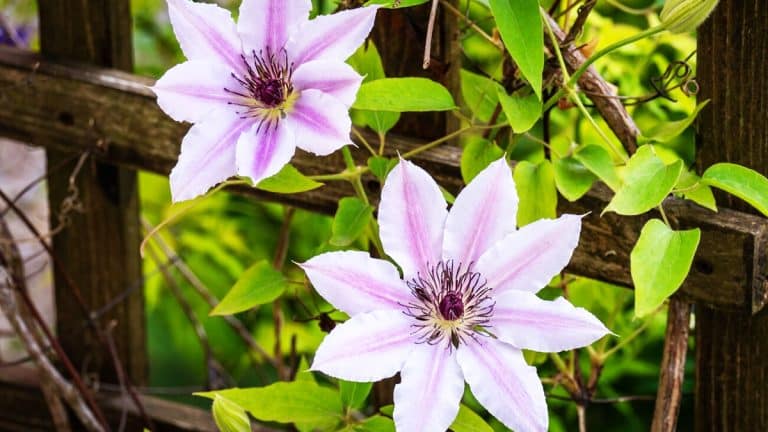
[0, 0, 768, 432]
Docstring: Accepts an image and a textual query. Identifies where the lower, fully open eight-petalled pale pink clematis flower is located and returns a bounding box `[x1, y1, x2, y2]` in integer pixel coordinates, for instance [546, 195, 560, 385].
[301, 158, 608, 432]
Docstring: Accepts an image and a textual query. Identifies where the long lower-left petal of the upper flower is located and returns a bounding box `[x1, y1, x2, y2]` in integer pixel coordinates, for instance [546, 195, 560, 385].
[170, 109, 250, 202]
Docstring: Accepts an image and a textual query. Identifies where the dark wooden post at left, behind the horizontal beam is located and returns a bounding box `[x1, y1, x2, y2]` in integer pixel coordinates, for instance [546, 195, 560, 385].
[37, 0, 147, 384]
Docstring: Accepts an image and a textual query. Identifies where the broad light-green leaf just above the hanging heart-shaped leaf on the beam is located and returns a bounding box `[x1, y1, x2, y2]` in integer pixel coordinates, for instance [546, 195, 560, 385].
[603, 145, 683, 216]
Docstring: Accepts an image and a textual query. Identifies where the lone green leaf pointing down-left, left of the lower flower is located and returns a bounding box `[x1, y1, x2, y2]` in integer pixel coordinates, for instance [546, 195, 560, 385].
[211, 260, 287, 315]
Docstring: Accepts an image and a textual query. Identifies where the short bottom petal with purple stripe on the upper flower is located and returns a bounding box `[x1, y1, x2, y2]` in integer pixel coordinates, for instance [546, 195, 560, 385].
[236, 121, 296, 184]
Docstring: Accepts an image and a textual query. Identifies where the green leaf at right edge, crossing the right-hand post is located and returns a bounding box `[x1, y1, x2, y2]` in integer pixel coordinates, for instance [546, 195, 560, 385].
[701, 163, 768, 217]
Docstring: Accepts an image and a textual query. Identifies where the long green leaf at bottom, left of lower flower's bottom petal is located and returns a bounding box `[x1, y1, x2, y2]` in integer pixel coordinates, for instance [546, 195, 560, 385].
[195, 381, 342, 429]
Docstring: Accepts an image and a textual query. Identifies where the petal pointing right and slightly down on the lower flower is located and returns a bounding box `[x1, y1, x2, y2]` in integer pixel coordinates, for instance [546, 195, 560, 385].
[490, 290, 610, 352]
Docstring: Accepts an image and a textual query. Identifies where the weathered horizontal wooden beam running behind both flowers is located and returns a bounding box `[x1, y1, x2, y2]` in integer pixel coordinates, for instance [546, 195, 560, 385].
[0, 48, 768, 312]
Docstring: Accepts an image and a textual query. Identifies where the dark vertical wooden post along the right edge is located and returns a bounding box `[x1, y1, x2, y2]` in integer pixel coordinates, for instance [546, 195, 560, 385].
[696, 0, 768, 432]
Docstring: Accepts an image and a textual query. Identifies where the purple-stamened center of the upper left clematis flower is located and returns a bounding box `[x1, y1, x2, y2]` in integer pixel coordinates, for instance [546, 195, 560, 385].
[224, 49, 298, 123]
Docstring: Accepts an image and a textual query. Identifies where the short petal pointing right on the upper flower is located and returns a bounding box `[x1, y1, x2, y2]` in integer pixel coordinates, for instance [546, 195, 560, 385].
[293, 60, 363, 107]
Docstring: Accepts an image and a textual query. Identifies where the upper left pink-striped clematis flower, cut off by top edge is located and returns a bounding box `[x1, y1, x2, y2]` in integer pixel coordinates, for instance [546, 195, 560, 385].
[153, 0, 377, 201]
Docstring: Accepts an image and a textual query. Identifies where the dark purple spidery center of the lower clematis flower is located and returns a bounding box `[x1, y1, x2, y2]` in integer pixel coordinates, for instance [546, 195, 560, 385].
[403, 261, 495, 348]
